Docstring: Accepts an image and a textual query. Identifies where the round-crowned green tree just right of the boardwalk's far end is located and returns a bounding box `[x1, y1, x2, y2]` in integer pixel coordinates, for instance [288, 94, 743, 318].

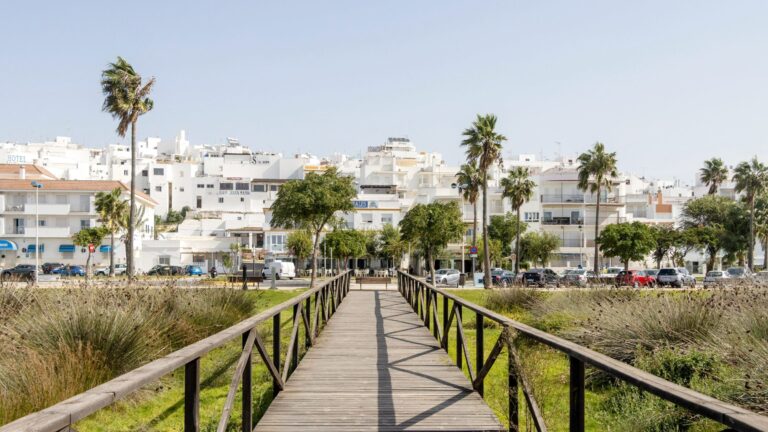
[400, 201, 462, 281]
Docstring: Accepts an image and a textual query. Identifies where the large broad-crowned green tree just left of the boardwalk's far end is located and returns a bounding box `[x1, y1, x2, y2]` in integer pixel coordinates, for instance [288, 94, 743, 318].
[270, 168, 355, 288]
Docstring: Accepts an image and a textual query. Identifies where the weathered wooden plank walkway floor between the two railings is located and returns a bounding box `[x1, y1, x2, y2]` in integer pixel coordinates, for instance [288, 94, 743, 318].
[255, 291, 505, 431]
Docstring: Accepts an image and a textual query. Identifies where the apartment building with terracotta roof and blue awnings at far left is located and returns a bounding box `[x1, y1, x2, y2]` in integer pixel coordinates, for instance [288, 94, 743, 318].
[0, 165, 156, 268]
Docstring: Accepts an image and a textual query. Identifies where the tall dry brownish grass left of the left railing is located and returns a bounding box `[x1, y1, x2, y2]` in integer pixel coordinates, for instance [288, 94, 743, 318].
[0, 285, 254, 424]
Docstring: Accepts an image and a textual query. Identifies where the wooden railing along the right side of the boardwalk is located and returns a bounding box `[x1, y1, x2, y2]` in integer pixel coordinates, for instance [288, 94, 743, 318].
[397, 272, 768, 431]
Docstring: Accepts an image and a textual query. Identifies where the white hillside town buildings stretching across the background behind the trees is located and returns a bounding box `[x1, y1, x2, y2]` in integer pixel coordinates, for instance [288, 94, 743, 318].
[0, 130, 764, 273]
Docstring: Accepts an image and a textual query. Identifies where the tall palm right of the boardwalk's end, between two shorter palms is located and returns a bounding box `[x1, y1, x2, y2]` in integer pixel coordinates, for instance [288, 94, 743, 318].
[461, 114, 507, 288]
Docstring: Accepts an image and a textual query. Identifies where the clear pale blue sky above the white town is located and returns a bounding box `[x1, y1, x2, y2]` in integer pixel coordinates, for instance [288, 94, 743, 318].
[0, 0, 768, 181]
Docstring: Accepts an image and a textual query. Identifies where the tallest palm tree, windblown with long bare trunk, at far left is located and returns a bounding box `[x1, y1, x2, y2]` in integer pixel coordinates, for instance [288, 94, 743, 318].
[101, 57, 155, 283]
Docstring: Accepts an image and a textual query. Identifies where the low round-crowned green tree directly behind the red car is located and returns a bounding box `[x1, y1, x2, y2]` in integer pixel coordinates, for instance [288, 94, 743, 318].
[600, 222, 656, 270]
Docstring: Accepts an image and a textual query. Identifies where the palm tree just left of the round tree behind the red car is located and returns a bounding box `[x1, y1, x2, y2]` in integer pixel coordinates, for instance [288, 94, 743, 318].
[578, 142, 619, 273]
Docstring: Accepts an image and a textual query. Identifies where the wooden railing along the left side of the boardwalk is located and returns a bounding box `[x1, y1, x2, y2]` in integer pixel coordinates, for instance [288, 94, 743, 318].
[0, 272, 351, 432]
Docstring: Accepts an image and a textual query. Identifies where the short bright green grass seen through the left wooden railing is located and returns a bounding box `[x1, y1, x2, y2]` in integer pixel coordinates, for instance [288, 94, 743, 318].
[75, 290, 304, 431]
